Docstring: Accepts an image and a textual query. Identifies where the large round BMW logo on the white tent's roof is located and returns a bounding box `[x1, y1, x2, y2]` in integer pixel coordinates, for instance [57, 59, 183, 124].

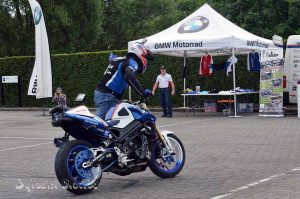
[178, 16, 209, 34]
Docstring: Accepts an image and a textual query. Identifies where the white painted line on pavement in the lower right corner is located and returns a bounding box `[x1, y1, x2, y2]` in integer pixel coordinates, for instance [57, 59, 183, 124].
[211, 167, 300, 199]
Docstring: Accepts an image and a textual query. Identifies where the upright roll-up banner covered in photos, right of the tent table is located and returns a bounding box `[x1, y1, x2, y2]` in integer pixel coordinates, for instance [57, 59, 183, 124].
[259, 49, 283, 117]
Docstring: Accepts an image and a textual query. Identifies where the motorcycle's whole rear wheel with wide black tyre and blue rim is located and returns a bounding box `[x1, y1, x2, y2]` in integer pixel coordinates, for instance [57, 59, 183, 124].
[55, 140, 102, 194]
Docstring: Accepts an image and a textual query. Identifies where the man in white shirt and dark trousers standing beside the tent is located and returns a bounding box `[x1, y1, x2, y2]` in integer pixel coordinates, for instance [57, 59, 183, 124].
[152, 66, 175, 118]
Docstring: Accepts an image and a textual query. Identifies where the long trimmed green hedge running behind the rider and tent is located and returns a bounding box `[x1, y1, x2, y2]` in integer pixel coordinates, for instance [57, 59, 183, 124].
[0, 50, 259, 107]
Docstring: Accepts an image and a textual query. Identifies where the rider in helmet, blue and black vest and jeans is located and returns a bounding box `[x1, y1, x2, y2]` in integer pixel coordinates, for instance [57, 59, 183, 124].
[94, 40, 153, 118]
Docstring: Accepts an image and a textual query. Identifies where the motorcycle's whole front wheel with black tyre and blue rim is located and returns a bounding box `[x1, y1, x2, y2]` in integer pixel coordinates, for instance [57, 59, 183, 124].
[149, 134, 185, 178]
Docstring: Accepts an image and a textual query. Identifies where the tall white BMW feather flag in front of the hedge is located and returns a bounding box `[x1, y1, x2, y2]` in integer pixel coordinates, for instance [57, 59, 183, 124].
[28, 0, 52, 99]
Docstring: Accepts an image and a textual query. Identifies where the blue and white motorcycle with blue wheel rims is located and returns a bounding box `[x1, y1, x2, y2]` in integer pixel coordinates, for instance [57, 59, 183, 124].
[50, 96, 185, 194]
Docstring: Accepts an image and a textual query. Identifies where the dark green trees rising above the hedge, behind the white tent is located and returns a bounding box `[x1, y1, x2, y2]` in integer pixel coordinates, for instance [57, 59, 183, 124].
[0, 0, 300, 57]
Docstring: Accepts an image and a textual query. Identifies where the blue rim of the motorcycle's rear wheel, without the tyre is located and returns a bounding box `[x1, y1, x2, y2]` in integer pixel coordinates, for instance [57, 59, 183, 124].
[67, 145, 102, 187]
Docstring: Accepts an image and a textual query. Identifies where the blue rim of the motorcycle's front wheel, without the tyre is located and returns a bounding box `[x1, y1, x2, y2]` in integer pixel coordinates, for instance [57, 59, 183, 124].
[153, 137, 184, 173]
